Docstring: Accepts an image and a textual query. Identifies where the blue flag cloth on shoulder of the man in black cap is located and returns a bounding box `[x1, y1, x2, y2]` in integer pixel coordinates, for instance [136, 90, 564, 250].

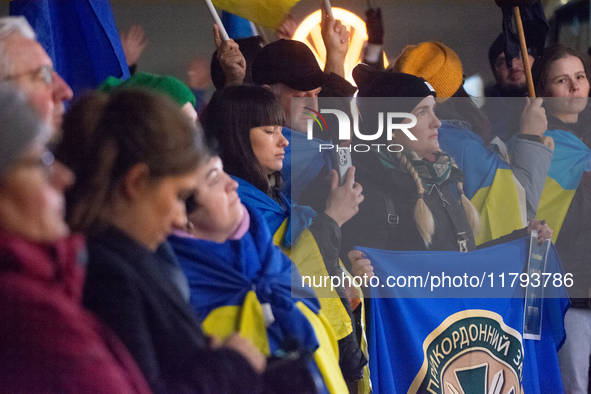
[281, 127, 333, 203]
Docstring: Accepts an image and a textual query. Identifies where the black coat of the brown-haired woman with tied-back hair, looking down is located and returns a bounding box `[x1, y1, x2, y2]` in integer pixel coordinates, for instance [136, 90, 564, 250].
[84, 228, 259, 393]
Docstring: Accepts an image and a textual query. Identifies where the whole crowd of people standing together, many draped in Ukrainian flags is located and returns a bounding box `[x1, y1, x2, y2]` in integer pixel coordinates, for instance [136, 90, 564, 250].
[0, 0, 591, 393]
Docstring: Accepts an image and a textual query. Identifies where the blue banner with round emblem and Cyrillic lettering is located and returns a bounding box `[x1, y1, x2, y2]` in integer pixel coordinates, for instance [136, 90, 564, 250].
[359, 238, 569, 394]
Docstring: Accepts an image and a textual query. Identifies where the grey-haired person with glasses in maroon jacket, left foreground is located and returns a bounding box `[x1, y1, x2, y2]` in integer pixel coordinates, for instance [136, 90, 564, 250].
[0, 84, 150, 394]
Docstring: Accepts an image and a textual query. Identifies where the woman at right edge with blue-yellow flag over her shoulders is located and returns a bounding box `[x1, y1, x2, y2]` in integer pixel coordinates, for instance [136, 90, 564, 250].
[532, 45, 591, 393]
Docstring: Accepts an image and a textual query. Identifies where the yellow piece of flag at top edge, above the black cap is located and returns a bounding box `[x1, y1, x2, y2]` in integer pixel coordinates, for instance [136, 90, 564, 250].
[212, 0, 299, 30]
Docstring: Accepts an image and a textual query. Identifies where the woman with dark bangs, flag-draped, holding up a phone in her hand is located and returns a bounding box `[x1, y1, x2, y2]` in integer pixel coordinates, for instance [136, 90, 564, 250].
[202, 86, 366, 390]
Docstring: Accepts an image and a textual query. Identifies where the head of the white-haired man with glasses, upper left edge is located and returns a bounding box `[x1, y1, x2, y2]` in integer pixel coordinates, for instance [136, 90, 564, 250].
[0, 16, 73, 136]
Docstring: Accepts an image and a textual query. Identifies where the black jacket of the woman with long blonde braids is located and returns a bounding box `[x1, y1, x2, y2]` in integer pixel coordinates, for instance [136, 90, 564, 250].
[341, 152, 476, 251]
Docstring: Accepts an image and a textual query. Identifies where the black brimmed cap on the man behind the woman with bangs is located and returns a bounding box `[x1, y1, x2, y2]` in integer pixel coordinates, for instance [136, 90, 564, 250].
[252, 39, 331, 92]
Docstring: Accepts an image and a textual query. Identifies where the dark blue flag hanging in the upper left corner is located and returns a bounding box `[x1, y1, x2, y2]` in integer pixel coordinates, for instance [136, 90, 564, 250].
[10, 0, 129, 94]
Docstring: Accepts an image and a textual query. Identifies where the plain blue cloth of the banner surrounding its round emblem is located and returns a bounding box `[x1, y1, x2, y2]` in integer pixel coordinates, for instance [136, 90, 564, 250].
[359, 238, 569, 393]
